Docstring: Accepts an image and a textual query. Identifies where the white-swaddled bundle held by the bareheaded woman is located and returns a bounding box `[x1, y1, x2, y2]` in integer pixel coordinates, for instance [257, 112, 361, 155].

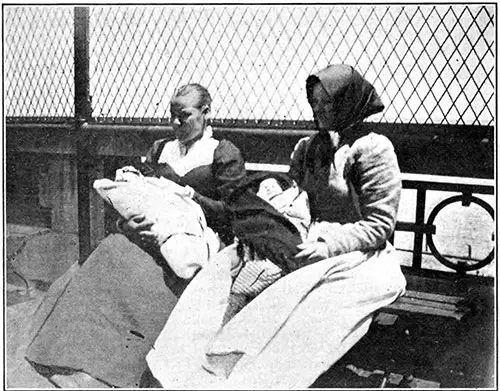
[94, 169, 219, 279]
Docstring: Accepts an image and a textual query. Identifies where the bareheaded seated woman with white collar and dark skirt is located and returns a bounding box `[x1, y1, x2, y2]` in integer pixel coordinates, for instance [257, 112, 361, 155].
[26, 84, 245, 388]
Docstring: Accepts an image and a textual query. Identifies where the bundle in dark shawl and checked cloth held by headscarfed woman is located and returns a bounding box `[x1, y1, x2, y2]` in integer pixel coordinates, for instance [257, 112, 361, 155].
[228, 173, 311, 298]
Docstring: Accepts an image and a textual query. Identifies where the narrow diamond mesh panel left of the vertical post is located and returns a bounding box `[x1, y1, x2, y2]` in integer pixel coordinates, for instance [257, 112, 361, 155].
[3, 6, 74, 121]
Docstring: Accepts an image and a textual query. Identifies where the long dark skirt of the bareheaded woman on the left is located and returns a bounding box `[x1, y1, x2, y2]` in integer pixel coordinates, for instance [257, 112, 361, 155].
[26, 234, 187, 388]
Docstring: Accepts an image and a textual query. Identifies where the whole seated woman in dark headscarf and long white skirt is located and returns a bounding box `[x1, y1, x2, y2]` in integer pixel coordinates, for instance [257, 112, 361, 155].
[148, 65, 405, 389]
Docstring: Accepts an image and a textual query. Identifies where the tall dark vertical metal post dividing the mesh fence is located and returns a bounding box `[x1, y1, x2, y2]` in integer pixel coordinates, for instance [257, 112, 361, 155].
[74, 7, 92, 264]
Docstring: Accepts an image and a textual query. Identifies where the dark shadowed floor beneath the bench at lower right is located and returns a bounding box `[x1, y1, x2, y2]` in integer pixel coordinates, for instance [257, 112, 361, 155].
[312, 278, 496, 389]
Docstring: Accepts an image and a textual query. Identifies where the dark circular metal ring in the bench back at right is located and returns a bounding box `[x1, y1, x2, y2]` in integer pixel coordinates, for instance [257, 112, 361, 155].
[426, 194, 495, 272]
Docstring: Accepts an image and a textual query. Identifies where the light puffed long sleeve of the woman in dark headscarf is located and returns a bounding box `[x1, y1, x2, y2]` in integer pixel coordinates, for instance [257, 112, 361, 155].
[314, 134, 401, 256]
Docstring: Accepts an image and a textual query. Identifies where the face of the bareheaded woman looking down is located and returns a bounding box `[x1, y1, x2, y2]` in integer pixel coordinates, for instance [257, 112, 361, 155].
[170, 91, 210, 144]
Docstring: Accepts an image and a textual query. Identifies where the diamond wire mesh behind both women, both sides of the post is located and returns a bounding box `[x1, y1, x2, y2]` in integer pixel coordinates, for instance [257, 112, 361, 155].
[5, 4, 495, 127]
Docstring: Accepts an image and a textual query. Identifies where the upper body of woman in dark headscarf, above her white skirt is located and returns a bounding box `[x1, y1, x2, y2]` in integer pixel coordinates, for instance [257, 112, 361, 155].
[289, 65, 401, 259]
